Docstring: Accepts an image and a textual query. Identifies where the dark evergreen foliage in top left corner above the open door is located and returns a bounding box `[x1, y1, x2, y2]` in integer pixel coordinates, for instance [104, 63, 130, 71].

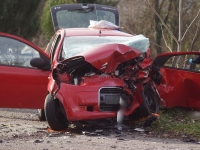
[0, 0, 41, 39]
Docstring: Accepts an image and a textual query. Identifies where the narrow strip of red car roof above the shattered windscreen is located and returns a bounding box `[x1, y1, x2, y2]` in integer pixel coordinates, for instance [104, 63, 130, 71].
[61, 28, 134, 37]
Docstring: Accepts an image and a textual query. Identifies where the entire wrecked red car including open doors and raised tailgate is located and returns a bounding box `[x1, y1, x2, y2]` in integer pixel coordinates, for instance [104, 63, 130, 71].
[0, 4, 200, 130]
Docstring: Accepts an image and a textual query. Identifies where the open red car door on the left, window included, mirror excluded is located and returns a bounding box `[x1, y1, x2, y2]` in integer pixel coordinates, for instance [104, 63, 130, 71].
[0, 33, 50, 109]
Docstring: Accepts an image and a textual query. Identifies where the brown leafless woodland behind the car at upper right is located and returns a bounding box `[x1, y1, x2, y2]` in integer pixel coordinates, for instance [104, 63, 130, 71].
[118, 0, 200, 56]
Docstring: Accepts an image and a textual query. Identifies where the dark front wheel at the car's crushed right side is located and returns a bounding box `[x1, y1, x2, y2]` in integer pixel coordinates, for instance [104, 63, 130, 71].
[129, 86, 159, 120]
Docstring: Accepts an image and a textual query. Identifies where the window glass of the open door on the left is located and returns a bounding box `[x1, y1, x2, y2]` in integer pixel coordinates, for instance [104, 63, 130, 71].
[0, 37, 40, 68]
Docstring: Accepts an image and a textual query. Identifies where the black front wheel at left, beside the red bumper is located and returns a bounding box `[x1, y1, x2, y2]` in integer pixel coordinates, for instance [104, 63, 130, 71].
[45, 94, 69, 131]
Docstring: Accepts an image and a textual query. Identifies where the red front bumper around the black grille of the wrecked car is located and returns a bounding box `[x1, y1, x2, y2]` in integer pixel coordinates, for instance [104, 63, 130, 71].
[56, 77, 139, 121]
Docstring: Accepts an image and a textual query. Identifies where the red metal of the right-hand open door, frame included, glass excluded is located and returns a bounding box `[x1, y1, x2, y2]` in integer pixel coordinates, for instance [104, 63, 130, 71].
[153, 52, 200, 110]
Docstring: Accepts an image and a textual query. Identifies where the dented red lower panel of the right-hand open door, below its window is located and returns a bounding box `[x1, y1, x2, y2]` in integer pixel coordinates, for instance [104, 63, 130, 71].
[157, 68, 200, 109]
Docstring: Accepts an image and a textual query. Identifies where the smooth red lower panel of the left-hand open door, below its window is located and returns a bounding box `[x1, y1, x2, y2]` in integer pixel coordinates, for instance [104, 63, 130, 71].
[0, 66, 49, 109]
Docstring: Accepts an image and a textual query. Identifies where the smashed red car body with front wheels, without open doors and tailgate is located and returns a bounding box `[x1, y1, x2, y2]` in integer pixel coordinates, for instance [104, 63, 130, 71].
[45, 29, 158, 130]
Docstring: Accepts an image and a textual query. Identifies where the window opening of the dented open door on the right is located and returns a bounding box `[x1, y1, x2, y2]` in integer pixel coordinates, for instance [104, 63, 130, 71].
[164, 54, 200, 72]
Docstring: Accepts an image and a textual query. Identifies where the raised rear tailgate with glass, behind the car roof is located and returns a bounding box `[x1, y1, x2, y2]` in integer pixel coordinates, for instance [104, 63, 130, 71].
[51, 4, 119, 31]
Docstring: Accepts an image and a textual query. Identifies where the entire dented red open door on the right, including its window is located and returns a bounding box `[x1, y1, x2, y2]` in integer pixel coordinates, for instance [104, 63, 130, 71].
[152, 52, 200, 110]
